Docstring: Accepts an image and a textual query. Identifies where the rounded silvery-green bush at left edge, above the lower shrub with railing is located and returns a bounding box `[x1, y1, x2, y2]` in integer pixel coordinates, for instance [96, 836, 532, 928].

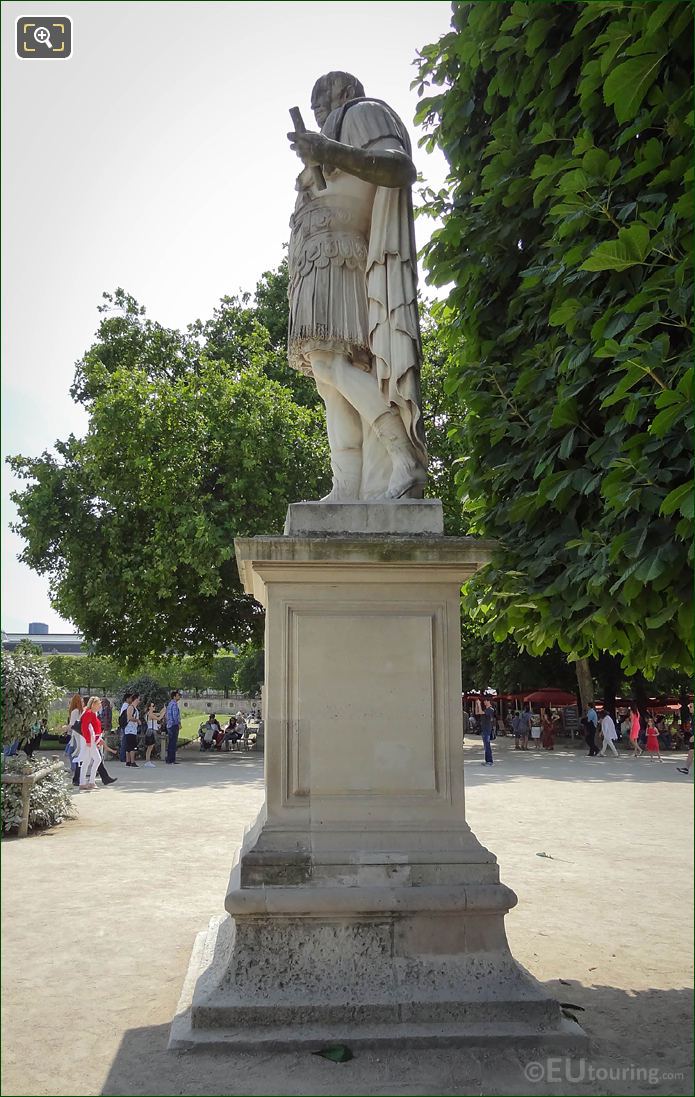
[0, 648, 60, 743]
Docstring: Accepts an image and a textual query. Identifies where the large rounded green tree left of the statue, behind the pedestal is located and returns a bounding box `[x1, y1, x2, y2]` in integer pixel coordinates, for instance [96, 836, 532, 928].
[10, 278, 330, 667]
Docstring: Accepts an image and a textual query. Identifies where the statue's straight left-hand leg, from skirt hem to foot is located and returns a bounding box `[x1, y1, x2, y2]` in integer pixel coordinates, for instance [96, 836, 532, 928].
[309, 351, 362, 502]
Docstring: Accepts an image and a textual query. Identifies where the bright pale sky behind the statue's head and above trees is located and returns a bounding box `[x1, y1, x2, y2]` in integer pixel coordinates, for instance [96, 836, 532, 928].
[0, 0, 451, 632]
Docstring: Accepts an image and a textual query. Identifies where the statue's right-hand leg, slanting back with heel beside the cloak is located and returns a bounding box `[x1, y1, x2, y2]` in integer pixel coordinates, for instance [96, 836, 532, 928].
[332, 355, 426, 499]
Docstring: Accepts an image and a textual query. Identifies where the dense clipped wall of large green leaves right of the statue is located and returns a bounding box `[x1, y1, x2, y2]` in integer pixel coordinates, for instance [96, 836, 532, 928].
[417, 0, 693, 674]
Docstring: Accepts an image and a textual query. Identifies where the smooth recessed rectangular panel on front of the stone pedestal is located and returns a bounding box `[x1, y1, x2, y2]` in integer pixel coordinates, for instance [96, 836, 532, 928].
[287, 600, 441, 798]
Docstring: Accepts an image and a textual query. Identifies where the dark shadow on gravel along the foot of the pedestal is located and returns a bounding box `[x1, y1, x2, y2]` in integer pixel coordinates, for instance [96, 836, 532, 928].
[101, 981, 693, 1097]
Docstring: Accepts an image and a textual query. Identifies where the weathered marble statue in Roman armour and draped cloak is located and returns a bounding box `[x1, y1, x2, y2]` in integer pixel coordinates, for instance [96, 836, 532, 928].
[287, 72, 426, 502]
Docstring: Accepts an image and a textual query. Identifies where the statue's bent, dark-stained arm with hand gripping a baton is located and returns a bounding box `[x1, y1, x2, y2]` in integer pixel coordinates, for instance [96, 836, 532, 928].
[287, 133, 417, 186]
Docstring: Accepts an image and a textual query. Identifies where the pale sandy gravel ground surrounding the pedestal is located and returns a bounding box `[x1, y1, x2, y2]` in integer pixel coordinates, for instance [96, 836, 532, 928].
[2, 737, 693, 1097]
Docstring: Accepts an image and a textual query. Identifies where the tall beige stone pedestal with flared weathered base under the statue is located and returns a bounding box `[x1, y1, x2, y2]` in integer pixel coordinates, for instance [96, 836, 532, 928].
[170, 505, 581, 1048]
